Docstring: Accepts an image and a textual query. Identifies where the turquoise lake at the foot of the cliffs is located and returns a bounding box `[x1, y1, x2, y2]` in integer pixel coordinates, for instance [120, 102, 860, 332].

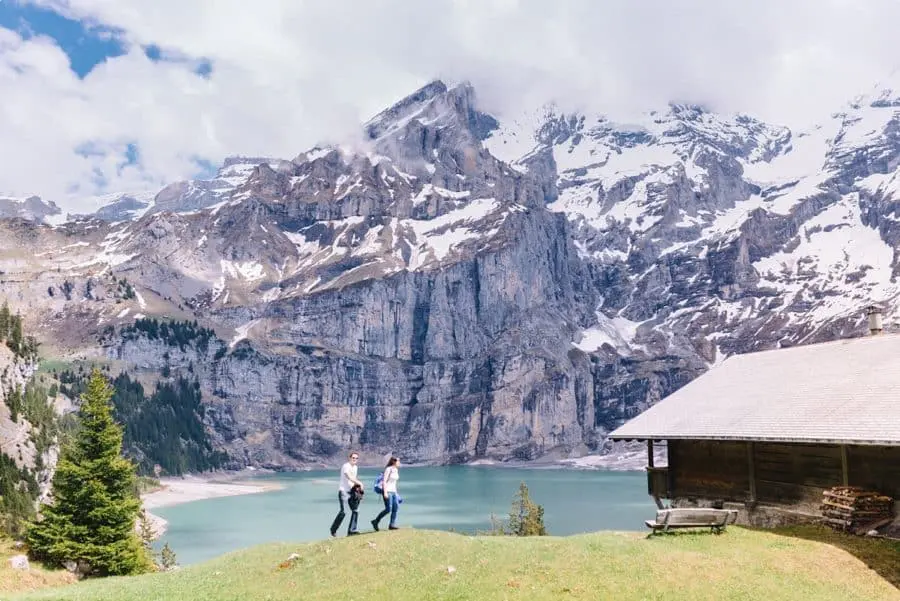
[154, 466, 656, 565]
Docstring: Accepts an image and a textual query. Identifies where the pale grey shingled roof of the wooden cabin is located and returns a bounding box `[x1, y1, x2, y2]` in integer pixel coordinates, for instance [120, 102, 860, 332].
[610, 334, 900, 446]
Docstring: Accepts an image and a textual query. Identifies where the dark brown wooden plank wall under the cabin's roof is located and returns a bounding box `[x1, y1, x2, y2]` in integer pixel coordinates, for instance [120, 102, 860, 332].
[668, 440, 900, 506]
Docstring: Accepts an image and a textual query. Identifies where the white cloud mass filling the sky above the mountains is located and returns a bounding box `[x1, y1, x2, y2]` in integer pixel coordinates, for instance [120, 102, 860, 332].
[0, 0, 900, 209]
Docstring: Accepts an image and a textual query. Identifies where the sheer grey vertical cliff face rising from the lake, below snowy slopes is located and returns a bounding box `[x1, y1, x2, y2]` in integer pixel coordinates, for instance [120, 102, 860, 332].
[236, 204, 595, 460]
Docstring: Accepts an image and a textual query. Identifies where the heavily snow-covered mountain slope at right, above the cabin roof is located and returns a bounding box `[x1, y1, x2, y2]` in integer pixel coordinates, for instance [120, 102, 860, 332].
[487, 89, 900, 360]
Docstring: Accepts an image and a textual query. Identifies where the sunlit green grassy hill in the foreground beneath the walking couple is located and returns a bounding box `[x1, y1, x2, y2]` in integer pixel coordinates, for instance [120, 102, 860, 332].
[1, 528, 900, 601]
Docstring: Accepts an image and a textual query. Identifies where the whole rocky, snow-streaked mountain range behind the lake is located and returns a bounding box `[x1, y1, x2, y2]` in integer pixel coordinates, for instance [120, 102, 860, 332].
[0, 77, 900, 465]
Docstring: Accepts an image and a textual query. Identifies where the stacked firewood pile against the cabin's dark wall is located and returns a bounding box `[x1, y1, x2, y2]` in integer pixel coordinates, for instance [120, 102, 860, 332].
[819, 486, 894, 532]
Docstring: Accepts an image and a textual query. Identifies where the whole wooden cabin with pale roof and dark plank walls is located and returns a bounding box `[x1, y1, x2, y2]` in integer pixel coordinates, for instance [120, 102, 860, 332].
[610, 318, 900, 525]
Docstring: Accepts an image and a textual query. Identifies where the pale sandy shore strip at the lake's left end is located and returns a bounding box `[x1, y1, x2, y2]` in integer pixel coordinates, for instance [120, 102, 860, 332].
[141, 471, 282, 539]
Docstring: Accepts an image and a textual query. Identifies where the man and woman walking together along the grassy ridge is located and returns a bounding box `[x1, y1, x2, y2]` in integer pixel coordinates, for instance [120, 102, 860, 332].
[331, 452, 403, 536]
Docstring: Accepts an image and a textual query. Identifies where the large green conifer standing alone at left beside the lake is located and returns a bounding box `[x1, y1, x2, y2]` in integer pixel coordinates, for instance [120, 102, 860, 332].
[26, 369, 152, 576]
